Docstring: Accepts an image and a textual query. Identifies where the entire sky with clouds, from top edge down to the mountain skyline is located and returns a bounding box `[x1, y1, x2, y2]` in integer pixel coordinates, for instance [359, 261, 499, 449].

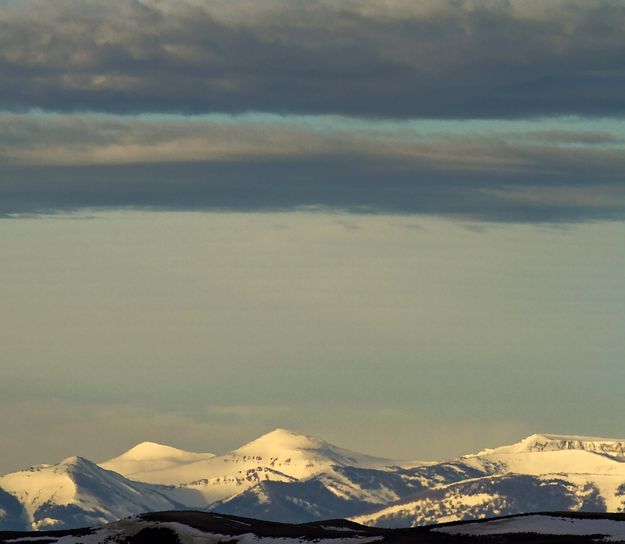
[0, 0, 625, 473]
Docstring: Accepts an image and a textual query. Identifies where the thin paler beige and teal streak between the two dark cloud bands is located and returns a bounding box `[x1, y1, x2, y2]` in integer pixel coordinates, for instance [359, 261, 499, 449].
[0, 113, 625, 169]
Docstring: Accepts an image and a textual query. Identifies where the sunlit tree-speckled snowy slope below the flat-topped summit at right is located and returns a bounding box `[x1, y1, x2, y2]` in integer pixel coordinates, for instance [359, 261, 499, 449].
[352, 435, 625, 527]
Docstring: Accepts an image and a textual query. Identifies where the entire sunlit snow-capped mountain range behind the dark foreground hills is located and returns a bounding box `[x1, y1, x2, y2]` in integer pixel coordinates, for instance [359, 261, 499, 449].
[0, 429, 625, 530]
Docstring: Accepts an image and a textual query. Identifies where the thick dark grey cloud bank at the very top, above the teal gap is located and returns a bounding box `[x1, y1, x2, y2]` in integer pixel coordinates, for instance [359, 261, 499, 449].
[0, 0, 625, 118]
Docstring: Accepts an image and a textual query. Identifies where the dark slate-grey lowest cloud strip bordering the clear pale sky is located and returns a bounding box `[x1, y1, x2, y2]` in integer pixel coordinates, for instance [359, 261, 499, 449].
[0, 157, 625, 222]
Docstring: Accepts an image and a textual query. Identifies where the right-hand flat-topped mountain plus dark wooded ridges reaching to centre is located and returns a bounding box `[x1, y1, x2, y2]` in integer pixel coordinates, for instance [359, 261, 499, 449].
[210, 435, 625, 527]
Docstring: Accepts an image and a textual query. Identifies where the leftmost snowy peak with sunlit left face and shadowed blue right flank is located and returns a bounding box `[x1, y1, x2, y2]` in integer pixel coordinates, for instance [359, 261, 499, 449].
[0, 457, 196, 529]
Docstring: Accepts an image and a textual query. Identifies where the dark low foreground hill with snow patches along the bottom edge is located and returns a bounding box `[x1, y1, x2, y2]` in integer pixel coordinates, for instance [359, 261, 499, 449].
[0, 511, 625, 544]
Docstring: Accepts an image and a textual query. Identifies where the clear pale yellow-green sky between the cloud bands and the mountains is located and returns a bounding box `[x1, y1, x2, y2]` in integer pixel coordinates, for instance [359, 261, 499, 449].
[0, 211, 625, 472]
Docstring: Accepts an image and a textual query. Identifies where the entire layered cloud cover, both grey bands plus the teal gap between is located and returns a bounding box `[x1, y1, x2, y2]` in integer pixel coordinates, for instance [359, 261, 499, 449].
[0, 0, 625, 222]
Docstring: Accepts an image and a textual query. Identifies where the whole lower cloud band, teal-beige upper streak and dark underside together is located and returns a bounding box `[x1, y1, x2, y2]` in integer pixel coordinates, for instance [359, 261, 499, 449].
[0, 113, 625, 222]
